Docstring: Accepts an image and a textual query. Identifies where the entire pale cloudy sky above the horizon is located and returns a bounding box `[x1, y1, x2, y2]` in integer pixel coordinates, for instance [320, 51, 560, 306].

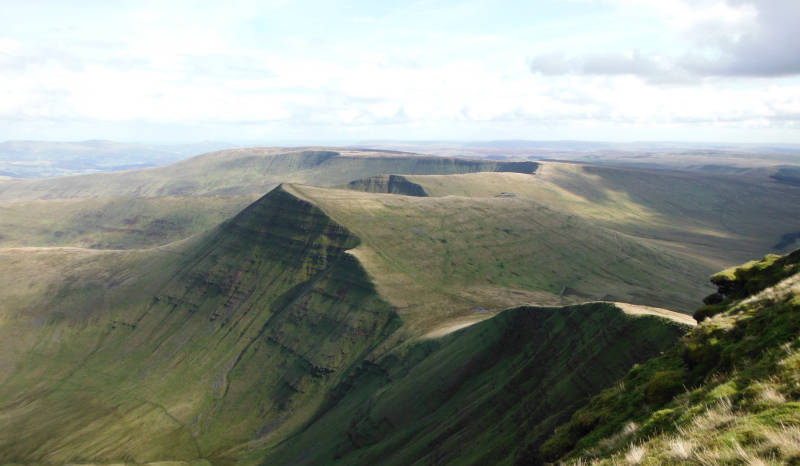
[0, 0, 800, 143]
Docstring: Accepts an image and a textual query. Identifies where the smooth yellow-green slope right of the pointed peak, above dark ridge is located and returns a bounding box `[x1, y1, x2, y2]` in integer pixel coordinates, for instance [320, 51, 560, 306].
[286, 184, 711, 327]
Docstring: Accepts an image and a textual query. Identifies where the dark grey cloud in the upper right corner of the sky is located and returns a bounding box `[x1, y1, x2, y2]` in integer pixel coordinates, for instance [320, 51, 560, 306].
[528, 0, 800, 79]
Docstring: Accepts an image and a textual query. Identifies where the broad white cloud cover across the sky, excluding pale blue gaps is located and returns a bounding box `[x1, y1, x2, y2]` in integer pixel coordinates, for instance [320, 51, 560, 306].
[0, 0, 800, 139]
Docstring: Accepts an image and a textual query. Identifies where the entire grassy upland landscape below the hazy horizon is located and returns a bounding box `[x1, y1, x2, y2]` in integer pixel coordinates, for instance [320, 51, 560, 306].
[0, 147, 800, 465]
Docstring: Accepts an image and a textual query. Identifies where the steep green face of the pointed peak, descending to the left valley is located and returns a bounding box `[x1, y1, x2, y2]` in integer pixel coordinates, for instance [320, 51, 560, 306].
[0, 190, 399, 464]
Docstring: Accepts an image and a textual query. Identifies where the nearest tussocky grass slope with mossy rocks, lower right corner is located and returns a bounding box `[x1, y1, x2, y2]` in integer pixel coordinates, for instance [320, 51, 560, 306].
[541, 250, 800, 465]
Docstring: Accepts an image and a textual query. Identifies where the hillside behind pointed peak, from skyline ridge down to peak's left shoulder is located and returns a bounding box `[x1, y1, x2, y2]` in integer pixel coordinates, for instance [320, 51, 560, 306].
[0, 148, 538, 249]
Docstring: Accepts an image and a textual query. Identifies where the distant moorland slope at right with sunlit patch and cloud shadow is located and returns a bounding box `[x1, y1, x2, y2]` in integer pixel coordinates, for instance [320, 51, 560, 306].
[388, 163, 800, 270]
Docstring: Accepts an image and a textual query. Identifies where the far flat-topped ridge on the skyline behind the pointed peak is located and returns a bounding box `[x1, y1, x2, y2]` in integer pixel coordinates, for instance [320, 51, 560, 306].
[0, 148, 537, 201]
